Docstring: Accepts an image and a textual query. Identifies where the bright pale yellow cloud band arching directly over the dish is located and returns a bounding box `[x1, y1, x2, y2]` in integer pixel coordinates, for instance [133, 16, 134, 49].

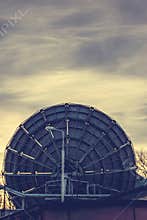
[0, 70, 147, 150]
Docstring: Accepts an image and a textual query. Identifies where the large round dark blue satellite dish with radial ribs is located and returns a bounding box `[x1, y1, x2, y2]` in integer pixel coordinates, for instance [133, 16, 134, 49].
[4, 103, 136, 206]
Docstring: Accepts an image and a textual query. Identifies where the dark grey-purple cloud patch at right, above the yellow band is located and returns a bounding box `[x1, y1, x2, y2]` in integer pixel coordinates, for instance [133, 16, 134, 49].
[74, 36, 145, 73]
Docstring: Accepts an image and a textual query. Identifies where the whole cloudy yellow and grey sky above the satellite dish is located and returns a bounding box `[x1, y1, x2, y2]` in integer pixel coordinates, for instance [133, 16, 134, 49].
[0, 0, 147, 168]
